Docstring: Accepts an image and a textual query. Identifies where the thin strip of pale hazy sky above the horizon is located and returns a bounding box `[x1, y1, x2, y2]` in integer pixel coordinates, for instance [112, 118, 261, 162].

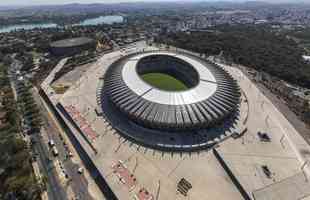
[0, 0, 302, 6]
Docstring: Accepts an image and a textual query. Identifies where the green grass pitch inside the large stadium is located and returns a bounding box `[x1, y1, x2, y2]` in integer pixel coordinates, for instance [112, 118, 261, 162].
[142, 73, 188, 91]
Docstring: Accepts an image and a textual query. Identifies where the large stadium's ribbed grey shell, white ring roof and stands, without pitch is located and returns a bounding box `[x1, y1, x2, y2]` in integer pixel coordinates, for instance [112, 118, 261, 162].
[104, 51, 240, 131]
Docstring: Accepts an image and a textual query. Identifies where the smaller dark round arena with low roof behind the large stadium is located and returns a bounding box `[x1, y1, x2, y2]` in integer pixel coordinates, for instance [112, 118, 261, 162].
[50, 37, 96, 56]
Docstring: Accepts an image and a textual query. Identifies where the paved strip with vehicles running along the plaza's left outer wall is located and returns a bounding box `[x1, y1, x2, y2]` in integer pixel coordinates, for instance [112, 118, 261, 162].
[33, 90, 93, 200]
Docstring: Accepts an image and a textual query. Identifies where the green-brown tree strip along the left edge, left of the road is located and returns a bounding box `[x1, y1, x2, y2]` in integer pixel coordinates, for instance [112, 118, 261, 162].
[0, 63, 41, 200]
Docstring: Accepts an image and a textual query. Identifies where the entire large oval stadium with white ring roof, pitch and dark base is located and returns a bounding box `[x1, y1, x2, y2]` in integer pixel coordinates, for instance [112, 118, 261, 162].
[101, 51, 240, 151]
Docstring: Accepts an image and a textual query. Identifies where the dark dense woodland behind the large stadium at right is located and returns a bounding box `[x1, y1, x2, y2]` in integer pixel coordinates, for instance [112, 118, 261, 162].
[155, 25, 310, 88]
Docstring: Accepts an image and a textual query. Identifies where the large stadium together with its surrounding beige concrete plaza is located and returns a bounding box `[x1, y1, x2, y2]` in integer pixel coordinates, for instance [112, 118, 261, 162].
[40, 41, 310, 200]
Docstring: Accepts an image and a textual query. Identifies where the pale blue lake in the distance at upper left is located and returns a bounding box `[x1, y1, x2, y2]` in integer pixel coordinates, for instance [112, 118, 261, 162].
[0, 15, 124, 33]
